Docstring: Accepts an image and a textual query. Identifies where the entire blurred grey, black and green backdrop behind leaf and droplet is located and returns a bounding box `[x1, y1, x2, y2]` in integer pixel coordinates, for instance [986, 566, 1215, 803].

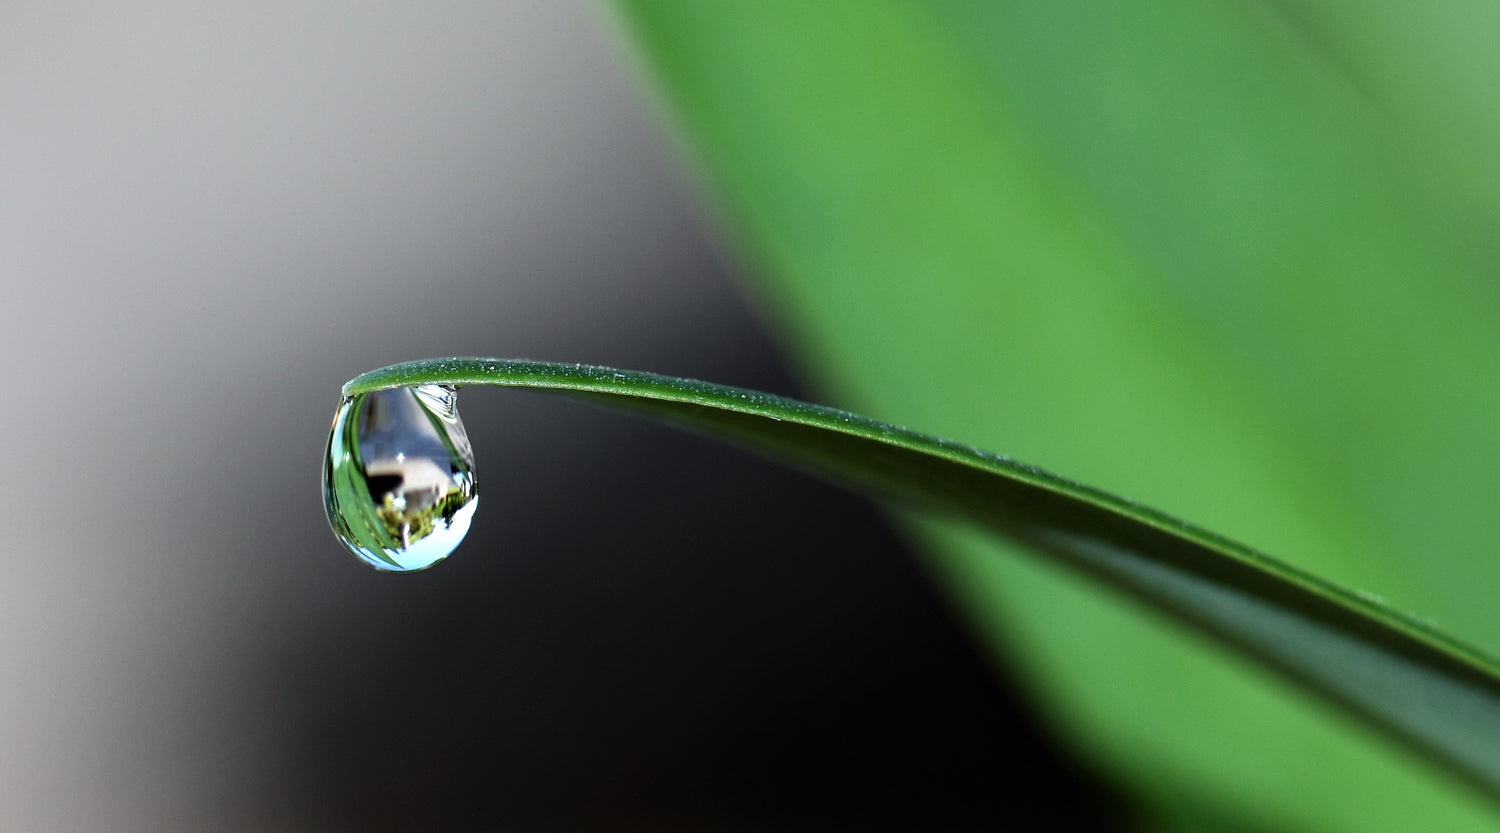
[0, 0, 1500, 833]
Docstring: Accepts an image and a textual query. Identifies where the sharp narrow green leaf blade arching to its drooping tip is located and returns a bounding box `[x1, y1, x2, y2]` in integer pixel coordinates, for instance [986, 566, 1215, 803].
[344, 359, 1500, 816]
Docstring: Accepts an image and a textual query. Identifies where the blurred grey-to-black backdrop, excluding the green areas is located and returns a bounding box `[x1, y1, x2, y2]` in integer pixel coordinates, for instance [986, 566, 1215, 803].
[0, 0, 1124, 831]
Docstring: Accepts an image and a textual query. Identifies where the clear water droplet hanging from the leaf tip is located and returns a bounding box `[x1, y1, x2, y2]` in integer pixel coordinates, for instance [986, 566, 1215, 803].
[323, 384, 479, 572]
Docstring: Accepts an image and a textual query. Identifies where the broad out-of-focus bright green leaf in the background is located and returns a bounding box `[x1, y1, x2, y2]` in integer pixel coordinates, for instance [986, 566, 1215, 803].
[620, 0, 1500, 831]
